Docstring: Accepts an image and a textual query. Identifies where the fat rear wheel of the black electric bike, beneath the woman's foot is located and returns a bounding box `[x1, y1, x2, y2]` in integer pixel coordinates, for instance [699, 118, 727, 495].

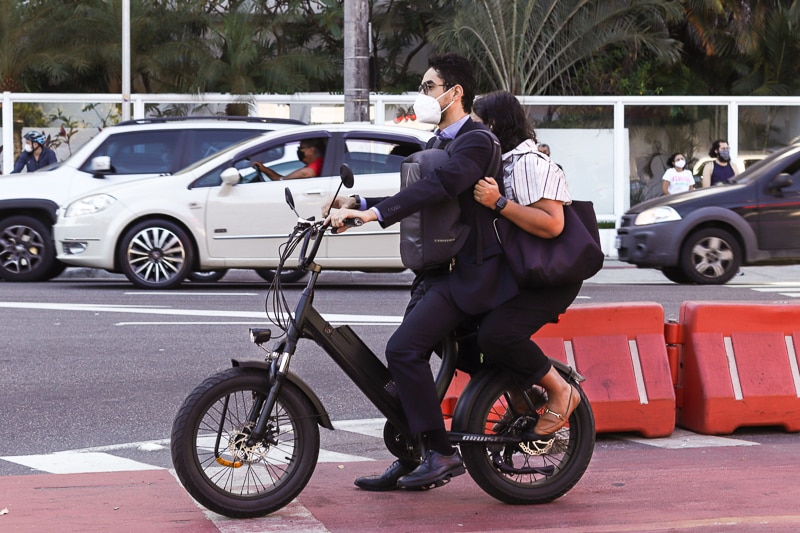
[453, 372, 595, 505]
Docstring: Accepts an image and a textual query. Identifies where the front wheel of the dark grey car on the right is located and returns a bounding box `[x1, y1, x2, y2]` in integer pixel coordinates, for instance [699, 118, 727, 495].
[681, 228, 742, 285]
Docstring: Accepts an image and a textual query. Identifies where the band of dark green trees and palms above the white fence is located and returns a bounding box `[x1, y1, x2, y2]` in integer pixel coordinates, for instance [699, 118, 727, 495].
[0, 0, 800, 100]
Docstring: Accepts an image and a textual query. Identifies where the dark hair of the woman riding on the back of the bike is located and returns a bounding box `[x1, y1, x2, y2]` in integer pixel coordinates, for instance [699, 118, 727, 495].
[473, 91, 536, 153]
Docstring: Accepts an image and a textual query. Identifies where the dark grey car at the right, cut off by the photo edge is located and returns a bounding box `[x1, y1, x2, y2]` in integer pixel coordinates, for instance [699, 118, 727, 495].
[616, 144, 800, 284]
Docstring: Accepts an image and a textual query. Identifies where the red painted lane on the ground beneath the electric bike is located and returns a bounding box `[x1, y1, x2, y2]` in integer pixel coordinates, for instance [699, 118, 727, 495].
[0, 439, 800, 533]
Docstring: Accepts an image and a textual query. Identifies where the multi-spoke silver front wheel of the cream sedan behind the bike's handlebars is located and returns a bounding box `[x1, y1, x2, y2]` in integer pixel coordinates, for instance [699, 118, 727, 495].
[118, 220, 194, 289]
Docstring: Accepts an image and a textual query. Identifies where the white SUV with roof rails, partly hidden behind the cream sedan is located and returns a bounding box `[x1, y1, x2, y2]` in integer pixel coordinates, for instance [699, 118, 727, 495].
[0, 117, 302, 281]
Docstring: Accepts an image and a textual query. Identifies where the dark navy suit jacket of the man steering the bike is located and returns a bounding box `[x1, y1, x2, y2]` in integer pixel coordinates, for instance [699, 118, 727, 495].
[367, 119, 519, 315]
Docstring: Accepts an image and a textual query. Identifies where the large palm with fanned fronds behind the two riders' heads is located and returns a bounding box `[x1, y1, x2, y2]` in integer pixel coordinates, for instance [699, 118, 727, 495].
[430, 0, 681, 95]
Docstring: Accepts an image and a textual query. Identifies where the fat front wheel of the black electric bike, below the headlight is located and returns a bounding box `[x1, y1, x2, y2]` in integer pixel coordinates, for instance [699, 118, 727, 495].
[171, 368, 319, 518]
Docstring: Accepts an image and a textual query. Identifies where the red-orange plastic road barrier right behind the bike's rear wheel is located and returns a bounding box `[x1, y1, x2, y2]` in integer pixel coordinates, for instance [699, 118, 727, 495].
[442, 302, 675, 437]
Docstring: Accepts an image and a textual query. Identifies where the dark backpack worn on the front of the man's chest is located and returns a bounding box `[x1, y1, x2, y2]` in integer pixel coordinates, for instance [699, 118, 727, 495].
[400, 129, 502, 270]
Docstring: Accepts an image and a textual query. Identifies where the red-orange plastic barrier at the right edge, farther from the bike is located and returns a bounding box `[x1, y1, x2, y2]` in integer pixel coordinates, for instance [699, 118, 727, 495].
[677, 302, 800, 434]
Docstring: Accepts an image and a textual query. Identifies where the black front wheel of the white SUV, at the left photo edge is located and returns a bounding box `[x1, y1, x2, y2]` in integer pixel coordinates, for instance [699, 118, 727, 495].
[0, 215, 60, 281]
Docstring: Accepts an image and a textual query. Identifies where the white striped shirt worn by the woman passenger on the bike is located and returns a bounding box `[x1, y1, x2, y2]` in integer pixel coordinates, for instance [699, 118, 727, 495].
[503, 139, 572, 205]
